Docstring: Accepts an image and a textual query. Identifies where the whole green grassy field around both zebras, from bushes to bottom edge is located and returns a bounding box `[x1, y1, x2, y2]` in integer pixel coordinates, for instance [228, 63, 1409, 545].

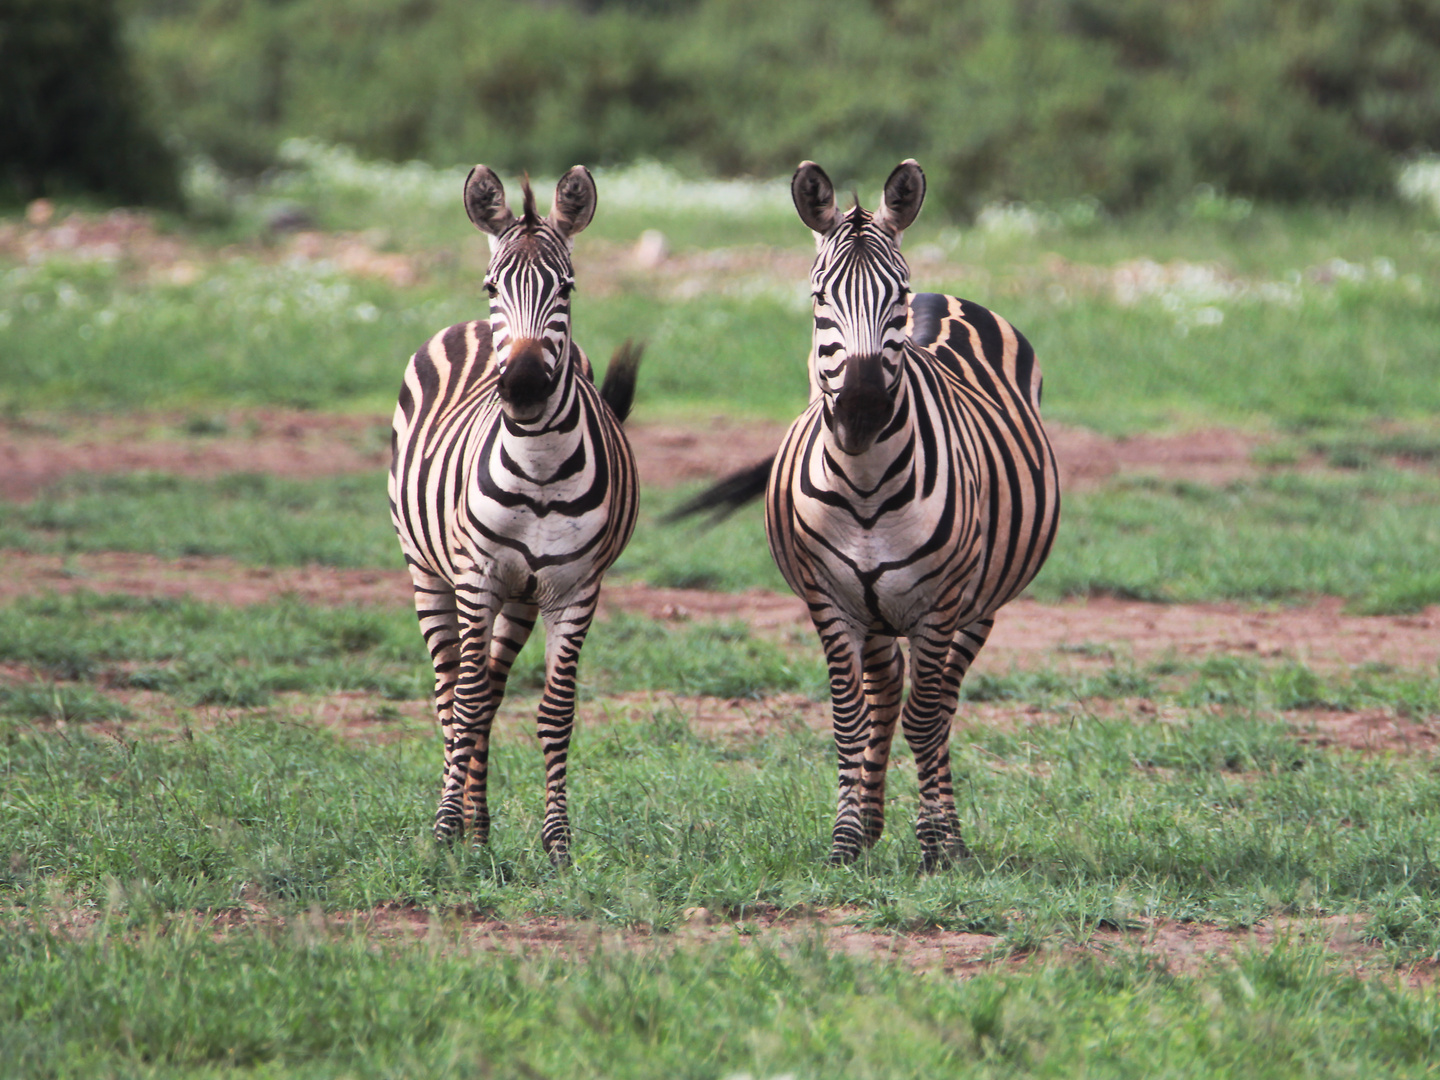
[8, 156, 1440, 1080]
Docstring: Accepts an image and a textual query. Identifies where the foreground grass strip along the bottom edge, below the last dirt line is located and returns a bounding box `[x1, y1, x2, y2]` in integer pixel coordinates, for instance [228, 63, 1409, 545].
[0, 920, 1440, 1080]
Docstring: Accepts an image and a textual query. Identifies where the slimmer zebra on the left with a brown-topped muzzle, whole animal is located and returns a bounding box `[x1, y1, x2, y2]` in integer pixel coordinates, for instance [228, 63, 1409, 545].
[390, 166, 639, 863]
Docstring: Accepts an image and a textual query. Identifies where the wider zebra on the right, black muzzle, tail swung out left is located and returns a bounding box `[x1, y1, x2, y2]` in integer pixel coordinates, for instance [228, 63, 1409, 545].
[675, 160, 1060, 868]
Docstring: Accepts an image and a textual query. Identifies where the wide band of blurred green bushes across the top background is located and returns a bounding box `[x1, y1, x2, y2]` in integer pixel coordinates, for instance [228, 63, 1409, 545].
[130, 0, 1440, 213]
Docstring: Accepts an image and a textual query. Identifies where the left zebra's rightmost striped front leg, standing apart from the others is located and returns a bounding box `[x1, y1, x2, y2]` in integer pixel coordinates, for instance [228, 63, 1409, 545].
[536, 589, 599, 865]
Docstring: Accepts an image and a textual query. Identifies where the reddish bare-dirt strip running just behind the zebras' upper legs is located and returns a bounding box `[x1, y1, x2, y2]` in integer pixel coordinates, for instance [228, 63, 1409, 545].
[0, 550, 1440, 674]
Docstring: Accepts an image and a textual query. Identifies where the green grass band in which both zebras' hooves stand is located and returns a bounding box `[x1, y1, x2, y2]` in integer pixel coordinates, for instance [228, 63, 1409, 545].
[8, 702, 1440, 956]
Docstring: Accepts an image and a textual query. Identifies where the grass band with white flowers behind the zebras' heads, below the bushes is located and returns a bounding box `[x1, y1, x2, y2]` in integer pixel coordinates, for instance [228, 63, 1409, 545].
[0, 199, 1440, 432]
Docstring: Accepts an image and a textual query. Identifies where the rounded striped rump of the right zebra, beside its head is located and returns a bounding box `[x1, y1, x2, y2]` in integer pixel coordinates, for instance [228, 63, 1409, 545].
[906, 292, 1041, 406]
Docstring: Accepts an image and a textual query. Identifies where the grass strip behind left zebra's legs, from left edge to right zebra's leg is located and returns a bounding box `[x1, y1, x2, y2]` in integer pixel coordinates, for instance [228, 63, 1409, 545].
[0, 592, 827, 717]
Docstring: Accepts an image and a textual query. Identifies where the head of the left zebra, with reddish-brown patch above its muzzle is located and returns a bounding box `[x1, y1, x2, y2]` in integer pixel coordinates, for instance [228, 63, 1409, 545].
[465, 166, 596, 423]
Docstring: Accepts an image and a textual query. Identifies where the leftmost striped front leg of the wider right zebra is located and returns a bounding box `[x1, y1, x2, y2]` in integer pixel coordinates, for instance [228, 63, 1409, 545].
[812, 608, 870, 865]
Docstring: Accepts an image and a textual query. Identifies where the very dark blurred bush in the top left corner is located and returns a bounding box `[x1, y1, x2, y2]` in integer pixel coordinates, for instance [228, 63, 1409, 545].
[0, 0, 179, 204]
